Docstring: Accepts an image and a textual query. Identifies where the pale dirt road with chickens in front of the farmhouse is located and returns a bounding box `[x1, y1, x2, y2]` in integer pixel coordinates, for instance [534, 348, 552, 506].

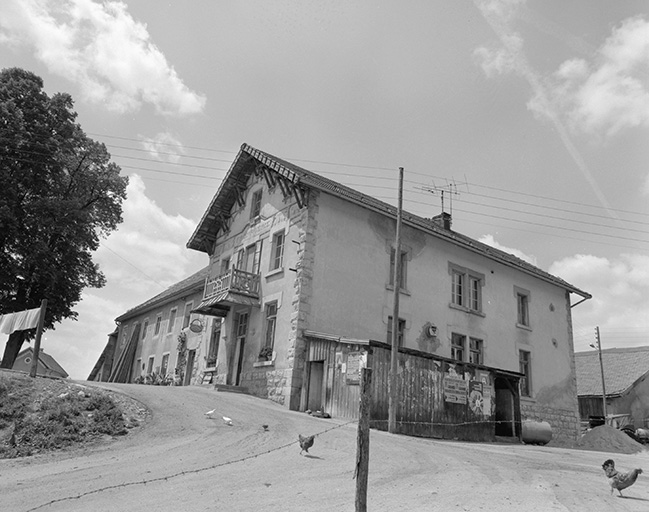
[0, 384, 649, 512]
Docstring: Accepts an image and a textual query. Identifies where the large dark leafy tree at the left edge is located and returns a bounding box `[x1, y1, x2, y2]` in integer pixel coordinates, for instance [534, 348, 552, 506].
[0, 68, 128, 368]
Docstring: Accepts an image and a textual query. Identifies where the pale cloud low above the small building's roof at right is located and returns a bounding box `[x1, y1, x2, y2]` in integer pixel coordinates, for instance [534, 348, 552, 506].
[550, 254, 649, 350]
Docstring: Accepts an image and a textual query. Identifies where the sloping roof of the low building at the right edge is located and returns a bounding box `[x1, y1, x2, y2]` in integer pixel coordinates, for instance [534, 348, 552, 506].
[575, 347, 649, 396]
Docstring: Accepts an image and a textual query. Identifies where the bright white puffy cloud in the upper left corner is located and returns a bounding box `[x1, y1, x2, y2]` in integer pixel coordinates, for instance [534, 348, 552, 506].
[0, 0, 205, 115]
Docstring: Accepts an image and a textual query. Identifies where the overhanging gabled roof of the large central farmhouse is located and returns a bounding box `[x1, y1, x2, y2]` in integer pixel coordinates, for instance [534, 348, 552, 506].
[187, 144, 591, 299]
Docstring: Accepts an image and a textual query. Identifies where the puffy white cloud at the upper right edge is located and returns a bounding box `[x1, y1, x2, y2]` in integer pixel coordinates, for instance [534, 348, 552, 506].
[530, 17, 649, 135]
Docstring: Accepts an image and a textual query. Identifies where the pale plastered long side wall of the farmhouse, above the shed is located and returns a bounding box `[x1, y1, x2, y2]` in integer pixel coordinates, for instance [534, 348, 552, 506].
[309, 190, 576, 418]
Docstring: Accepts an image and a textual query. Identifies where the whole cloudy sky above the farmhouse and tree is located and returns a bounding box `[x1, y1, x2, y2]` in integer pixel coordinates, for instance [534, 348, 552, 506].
[0, 0, 649, 379]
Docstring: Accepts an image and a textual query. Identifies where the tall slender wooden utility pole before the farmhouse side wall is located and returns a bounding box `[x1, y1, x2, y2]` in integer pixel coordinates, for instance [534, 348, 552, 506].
[388, 167, 403, 434]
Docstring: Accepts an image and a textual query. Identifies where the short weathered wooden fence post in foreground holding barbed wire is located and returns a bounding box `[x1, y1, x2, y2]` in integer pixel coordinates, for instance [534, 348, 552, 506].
[354, 368, 372, 512]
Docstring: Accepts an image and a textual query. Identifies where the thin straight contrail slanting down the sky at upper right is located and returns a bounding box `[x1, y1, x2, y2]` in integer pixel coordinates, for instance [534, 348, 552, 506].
[474, 0, 619, 220]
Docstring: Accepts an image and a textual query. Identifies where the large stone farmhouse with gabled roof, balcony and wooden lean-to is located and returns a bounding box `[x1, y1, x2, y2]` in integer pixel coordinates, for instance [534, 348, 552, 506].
[95, 144, 590, 444]
